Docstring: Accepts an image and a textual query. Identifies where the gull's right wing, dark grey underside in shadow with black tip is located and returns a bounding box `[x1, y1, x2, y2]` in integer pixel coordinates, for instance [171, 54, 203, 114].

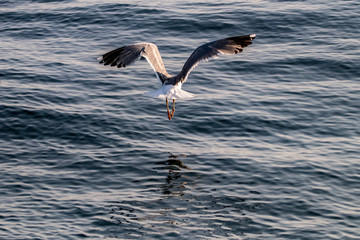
[176, 34, 256, 82]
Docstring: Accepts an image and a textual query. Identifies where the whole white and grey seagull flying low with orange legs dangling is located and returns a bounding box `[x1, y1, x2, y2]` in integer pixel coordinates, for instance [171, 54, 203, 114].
[98, 34, 256, 120]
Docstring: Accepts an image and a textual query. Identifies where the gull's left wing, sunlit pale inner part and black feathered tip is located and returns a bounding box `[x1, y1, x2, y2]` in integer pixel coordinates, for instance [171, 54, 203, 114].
[98, 43, 169, 83]
